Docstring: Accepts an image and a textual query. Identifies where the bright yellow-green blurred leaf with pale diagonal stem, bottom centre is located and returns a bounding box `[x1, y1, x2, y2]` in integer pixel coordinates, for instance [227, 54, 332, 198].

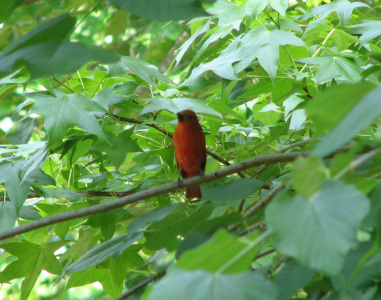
[175, 230, 263, 273]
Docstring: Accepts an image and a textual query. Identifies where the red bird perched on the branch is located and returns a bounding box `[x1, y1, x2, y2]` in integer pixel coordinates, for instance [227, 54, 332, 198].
[173, 110, 206, 199]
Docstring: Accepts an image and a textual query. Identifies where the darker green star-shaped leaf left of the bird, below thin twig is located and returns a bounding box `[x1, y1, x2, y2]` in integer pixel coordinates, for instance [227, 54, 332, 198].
[90, 130, 143, 168]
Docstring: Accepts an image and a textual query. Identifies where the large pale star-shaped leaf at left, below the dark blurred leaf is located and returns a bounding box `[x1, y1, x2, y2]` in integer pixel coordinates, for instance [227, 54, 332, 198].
[28, 91, 107, 145]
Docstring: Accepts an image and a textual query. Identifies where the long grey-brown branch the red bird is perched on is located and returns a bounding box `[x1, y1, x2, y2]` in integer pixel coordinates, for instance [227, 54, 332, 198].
[0, 151, 311, 240]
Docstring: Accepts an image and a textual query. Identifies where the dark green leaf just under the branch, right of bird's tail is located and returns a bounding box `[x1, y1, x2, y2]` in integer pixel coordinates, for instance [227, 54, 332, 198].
[202, 179, 263, 205]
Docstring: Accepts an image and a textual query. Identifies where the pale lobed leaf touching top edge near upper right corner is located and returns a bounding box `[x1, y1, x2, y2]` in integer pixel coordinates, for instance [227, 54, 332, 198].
[302, 0, 370, 33]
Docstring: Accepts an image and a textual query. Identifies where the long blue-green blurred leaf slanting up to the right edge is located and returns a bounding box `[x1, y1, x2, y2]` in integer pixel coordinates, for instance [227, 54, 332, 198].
[312, 86, 381, 157]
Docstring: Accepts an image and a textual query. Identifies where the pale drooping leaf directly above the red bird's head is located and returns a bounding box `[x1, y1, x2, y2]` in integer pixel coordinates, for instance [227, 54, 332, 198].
[140, 98, 222, 118]
